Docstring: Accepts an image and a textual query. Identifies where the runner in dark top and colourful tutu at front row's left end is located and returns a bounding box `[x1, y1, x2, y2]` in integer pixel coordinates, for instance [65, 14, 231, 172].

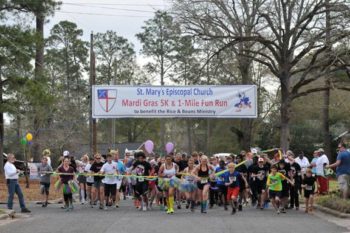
[57, 157, 74, 211]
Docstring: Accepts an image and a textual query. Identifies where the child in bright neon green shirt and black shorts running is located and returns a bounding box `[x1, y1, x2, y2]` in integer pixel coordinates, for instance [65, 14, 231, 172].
[266, 165, 294, 214]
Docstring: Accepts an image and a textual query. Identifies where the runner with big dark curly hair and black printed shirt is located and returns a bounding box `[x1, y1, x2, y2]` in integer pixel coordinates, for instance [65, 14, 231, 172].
[132, 151, 151, 211]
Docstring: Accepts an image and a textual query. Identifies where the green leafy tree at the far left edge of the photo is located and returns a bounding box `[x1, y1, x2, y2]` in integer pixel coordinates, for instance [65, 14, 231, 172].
[0, 25, 34, 173]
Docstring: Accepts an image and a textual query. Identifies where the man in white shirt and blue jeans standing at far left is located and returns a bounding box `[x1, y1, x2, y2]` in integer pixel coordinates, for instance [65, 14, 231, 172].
[4, 154, 30, 213]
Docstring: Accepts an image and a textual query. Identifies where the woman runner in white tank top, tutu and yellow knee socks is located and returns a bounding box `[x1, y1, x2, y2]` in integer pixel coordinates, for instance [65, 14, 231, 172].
[158, 155, 179, 214]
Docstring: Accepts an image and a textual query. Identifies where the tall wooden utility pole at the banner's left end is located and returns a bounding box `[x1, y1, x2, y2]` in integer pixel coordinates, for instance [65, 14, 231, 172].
[89, 32, 97, 154]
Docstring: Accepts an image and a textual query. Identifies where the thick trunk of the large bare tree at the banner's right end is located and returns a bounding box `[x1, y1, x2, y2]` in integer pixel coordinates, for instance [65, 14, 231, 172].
[280, 73, 292, 151]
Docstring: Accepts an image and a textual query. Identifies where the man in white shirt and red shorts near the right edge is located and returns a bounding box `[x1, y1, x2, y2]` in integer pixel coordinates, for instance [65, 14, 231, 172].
[316, 148, 329, 194]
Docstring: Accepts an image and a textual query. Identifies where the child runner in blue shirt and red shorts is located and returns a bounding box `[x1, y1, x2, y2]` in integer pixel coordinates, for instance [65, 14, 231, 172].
[223, 163, 248, 214]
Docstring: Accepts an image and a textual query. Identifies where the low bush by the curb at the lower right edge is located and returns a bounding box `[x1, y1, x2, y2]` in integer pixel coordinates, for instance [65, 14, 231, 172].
[316, 194, 350, 214]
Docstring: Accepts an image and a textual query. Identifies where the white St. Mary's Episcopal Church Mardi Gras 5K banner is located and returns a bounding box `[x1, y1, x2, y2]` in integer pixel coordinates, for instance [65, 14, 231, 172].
[92, 85, 257, 118]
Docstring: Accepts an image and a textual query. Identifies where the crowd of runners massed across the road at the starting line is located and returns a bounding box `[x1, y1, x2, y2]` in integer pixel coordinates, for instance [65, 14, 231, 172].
[5, 143, 350, 214]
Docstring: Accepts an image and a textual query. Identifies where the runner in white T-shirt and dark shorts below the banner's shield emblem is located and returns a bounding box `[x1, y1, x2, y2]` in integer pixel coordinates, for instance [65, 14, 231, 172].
[101, 154, 118, 210]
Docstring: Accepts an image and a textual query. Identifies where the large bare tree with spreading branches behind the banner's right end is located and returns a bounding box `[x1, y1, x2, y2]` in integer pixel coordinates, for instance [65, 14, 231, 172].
[177, 0, 349, 149]
